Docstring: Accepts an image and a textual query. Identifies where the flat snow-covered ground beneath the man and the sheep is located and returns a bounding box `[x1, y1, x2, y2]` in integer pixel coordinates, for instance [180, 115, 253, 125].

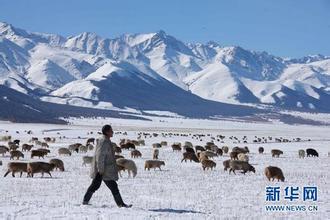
[0, 117, 330, 219]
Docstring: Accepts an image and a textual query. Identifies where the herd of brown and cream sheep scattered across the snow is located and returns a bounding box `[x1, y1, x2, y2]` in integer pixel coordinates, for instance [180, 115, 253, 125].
[0, 131, 319, 181]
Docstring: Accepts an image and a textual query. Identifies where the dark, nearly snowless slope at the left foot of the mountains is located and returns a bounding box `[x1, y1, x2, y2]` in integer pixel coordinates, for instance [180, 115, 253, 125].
[0, 85, 150, 124]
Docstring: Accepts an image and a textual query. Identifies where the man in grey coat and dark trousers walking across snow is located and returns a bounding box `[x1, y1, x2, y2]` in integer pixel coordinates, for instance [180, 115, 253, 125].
[83, 125, 132, 208]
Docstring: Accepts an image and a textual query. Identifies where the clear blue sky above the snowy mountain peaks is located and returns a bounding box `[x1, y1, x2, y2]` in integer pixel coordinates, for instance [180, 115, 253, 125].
[0, 0, 330, 57]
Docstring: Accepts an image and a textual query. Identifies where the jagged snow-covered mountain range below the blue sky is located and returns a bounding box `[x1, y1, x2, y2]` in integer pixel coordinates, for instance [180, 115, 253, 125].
[0, 23, 330, 121]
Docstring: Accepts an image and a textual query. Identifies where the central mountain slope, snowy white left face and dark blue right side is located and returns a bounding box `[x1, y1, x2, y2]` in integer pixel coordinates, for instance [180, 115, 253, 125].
[44, 62, 263, 118]
